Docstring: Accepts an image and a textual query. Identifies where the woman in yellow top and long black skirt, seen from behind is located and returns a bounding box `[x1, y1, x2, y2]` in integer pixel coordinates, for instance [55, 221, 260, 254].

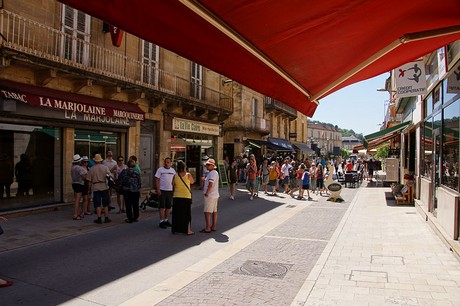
[171, 160, 195, 235]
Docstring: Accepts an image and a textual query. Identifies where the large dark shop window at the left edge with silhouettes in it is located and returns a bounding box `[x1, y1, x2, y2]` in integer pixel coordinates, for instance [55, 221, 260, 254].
[0, 124, 61, 211]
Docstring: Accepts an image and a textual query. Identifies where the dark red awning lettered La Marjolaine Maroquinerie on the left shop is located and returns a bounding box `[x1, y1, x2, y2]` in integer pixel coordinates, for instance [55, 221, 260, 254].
[0, 80, 145, 121]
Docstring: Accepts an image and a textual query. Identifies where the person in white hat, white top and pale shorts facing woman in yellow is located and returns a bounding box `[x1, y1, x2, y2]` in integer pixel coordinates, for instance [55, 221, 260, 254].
[200, 158, 219, 234]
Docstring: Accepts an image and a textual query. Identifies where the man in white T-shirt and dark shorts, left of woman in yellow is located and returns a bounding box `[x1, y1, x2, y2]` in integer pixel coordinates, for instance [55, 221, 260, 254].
[155, 157, 176, 228]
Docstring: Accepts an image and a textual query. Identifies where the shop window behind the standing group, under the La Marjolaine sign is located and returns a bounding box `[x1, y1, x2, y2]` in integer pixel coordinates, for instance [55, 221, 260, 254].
[74, 130, 120, 158]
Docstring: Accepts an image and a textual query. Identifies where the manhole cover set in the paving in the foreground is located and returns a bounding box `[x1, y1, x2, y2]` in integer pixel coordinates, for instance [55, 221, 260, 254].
[234, 260, 292, 279]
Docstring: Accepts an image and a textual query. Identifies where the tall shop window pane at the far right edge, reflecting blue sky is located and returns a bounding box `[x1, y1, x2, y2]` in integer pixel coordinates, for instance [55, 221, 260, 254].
[441, 100, 460, 191]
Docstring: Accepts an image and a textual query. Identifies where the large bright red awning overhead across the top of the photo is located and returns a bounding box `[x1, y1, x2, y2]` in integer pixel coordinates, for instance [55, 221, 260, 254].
[56, 0, 460, 116]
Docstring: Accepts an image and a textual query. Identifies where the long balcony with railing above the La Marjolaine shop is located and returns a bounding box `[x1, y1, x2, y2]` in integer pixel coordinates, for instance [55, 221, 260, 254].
[0, 10, 233, 116]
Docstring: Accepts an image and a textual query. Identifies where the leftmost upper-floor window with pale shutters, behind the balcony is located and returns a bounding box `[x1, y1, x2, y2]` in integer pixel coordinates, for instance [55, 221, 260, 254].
[61, 5, 90, 65]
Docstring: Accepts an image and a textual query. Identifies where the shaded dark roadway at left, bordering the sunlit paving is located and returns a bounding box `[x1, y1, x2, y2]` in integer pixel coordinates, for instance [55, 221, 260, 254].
[0, 192, 286, 305]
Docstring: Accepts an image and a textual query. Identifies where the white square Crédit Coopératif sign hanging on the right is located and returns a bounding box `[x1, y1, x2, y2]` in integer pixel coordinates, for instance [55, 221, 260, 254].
[393, 61, 426, 98]
